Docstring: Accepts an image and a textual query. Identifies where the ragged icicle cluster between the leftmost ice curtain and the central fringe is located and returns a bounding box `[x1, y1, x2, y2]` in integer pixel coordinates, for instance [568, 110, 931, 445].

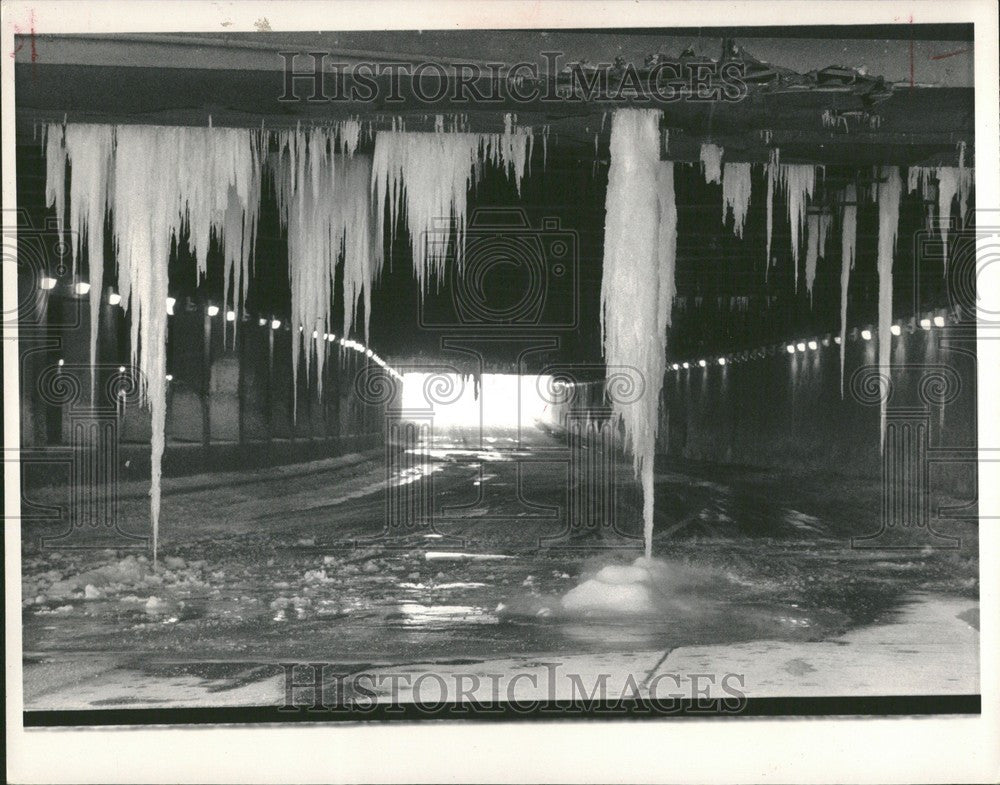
[274, 121, 382, 408]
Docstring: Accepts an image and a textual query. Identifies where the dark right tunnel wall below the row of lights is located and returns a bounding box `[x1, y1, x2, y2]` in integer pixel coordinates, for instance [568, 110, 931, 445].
[659, 327, 976, 490]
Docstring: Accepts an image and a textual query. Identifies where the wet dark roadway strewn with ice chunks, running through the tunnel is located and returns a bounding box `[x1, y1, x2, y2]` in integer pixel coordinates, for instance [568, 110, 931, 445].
[22, 431, 978, 708]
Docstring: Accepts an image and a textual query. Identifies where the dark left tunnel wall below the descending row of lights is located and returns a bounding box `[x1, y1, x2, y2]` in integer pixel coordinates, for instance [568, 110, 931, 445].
[20, 290, 385, 486]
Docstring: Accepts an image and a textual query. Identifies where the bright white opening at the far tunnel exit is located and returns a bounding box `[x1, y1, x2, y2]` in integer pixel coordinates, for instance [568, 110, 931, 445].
[401, 371, 562, 429]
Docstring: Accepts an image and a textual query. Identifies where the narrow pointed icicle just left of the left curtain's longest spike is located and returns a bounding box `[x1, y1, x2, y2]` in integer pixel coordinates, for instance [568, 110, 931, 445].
[66, 124, 114, 398]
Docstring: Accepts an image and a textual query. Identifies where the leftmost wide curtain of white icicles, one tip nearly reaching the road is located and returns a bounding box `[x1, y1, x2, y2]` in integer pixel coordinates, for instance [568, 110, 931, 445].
[45, 124, 261, 559]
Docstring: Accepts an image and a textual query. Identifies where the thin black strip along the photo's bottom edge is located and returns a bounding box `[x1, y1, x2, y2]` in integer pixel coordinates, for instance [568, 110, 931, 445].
[24, 695, 982, 728]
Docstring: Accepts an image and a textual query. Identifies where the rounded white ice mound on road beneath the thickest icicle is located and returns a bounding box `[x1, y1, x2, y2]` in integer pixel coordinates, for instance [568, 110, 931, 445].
[562, 557, 665, 615]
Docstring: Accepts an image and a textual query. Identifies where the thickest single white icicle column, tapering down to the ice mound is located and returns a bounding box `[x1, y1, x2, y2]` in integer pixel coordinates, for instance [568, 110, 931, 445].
[601, 109, 677, 554]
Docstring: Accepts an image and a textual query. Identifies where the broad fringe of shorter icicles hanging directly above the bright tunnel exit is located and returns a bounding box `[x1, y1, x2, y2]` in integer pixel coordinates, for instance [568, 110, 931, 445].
[371, 115, 544, 294]
